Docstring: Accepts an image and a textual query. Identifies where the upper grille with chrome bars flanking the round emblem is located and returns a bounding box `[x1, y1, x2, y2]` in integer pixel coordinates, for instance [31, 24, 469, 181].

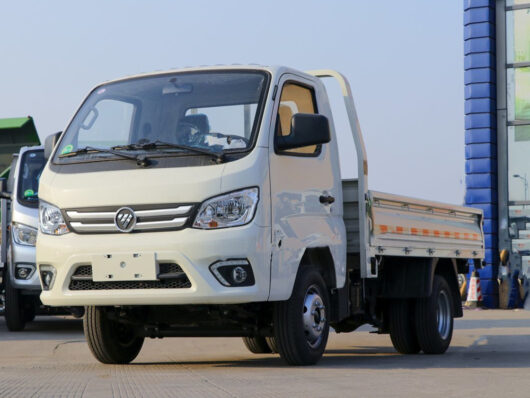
[63, 204, 196, 234]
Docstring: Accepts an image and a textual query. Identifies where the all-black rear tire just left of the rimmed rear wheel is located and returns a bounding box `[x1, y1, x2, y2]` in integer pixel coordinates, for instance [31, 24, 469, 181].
[388, 299, 421, 354]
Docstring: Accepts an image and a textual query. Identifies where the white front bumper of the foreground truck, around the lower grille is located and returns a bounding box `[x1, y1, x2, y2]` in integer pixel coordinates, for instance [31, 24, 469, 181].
[37, 223, 271, 306]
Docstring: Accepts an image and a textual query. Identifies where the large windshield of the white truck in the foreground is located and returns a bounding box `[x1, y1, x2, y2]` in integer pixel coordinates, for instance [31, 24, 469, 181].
[54, 71, 268, 163]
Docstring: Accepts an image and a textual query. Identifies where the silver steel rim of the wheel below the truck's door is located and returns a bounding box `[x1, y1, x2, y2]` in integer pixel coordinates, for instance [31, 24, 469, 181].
[302, 285, 327, 348]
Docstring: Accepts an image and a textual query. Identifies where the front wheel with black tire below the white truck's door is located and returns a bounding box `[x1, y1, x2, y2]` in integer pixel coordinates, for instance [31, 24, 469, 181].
[274, 266, 330, 366]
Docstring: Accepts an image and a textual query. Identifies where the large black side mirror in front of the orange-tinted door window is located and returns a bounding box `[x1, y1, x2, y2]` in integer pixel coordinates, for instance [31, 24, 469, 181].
[276, 113, 331, 151]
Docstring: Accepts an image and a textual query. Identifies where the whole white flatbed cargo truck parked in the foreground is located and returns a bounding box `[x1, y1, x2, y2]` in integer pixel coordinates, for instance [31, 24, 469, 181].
[37, 65, 484, 365]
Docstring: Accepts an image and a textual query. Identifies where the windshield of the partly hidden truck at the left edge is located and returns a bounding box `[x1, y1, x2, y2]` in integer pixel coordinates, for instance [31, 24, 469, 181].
[17, 149, 46, 207]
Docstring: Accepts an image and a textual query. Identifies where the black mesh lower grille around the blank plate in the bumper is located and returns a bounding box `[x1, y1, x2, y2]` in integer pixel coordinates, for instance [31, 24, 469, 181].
[69, 263, 191, 290]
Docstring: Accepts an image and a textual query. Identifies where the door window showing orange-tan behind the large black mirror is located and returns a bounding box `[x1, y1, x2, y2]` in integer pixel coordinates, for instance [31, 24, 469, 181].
[276, 83, 320, 156]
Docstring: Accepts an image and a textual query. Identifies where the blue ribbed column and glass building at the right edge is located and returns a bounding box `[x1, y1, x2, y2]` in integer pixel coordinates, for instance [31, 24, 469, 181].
[464, 0, 530, 308]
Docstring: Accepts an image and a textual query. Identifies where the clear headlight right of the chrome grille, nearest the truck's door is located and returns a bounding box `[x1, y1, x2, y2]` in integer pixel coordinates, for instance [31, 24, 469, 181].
[193, 188, 259, 229]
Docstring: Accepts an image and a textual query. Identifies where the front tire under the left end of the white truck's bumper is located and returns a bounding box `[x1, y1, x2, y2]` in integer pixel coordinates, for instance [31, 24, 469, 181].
[83, 306, 144, 364]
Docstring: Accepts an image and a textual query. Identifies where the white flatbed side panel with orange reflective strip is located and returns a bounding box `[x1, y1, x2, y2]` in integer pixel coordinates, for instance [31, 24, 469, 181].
[368, 191, 484, 259]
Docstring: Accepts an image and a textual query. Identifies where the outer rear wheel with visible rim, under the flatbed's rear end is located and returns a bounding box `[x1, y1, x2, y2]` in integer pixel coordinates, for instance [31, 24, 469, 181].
[415, 275, 454, 354]
